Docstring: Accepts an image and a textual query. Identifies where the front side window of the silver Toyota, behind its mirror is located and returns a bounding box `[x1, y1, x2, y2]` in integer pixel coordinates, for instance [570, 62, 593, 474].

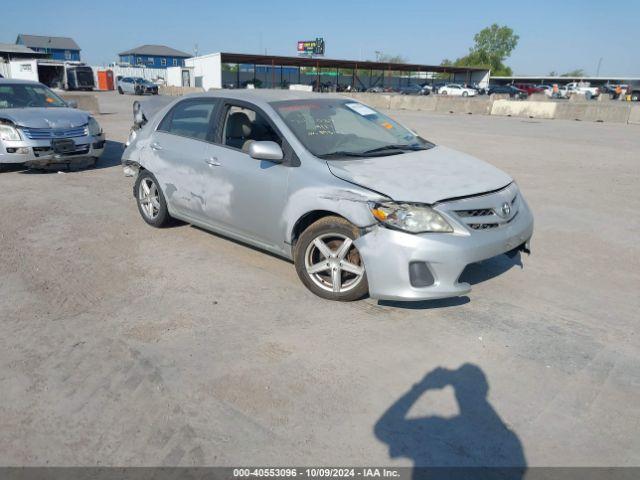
[222, 105, 282, 151]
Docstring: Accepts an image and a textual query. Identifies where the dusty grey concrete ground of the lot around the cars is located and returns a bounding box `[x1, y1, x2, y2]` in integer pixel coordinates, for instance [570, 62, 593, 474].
[0, 93, 640, 466]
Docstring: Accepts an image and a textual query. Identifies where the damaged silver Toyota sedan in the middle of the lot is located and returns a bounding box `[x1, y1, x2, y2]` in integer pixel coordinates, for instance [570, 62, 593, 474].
[123, 90, 533, 300]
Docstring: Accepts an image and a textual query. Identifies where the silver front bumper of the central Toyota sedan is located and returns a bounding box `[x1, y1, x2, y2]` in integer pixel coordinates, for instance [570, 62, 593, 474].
[354, 202, 533, 301]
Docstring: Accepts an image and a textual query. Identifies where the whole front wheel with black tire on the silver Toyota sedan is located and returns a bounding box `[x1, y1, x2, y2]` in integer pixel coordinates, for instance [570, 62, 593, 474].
[294, 216, 369, 302]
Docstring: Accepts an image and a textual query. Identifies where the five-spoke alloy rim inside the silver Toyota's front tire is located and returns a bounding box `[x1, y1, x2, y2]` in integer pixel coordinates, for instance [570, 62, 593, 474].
[304, 233, 365, 293]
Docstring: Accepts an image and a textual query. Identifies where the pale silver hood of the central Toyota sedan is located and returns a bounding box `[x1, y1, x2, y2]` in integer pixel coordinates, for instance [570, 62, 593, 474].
[327, 146, 513, 204]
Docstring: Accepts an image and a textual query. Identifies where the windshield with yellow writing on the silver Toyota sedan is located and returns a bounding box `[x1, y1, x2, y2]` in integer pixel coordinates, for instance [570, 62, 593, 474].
[271, 99, 433, 158]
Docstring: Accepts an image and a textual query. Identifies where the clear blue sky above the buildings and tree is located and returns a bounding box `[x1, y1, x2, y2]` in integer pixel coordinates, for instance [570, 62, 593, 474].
[0, 0, 640, 76]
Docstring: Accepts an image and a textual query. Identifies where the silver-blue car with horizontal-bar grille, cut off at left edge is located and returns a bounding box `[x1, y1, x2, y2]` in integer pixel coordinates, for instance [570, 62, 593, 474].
[0, 79, 105, 167]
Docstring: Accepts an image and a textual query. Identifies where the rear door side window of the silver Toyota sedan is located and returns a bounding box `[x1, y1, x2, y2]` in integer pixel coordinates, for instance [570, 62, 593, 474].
[158, 100, 216, 140]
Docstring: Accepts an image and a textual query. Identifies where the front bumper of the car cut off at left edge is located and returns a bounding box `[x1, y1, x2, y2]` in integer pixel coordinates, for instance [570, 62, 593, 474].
[0, 133, 106, 168]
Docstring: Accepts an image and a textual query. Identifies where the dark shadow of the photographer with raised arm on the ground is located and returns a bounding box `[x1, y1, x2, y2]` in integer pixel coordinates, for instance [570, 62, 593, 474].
[374, 363, 526, 479]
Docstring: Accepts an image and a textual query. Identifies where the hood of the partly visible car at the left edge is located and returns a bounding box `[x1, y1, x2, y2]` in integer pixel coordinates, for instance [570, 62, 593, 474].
[0, 107, 89, 128]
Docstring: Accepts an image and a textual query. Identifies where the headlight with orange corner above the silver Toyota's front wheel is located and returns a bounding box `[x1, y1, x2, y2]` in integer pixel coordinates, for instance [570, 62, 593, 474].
[371, 202, 453, 233]
